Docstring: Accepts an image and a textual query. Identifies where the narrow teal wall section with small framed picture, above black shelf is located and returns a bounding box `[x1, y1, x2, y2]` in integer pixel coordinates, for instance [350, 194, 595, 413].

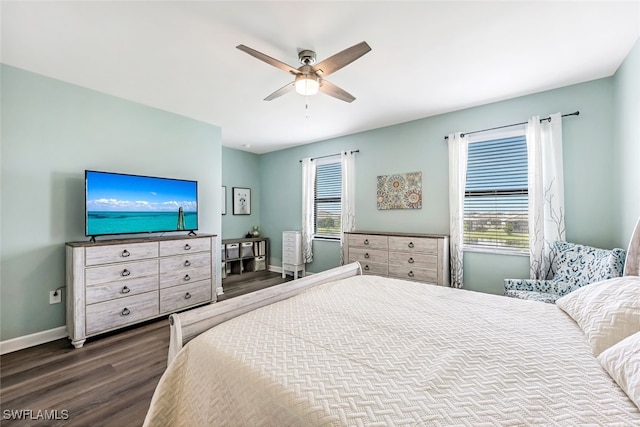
[222, 147, 262, 239]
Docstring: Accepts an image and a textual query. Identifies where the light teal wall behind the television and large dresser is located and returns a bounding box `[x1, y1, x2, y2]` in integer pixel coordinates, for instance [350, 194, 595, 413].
[0, 65, 222, 341]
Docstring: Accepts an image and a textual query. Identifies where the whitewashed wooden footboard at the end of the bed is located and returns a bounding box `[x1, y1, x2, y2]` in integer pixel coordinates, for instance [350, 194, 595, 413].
[167, 262, 362, 364]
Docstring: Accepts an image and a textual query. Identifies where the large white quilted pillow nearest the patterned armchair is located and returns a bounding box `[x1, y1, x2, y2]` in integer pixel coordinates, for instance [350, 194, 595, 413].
[556, 276, 640, 356]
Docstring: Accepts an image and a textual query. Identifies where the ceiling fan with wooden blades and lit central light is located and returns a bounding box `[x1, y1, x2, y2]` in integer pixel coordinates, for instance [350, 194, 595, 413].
[236, 42, 371, 102]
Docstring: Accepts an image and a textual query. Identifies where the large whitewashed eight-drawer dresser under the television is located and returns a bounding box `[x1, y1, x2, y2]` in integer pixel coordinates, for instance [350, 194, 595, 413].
[66, 235, 218, 348]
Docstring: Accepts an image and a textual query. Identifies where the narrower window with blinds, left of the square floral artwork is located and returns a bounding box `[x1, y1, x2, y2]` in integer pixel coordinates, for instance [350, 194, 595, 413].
[313, 157, 342, 239]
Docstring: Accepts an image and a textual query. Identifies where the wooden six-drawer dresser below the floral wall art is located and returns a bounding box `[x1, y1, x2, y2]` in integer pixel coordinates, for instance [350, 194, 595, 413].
[344, 231, 449, 286]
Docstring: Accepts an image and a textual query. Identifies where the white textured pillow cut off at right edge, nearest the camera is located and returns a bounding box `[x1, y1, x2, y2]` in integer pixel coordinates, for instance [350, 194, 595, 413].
[598, 332, 640, 408]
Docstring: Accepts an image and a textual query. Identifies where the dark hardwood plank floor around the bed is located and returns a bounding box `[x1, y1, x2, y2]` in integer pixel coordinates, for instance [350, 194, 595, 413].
[0, 271, 291, 427]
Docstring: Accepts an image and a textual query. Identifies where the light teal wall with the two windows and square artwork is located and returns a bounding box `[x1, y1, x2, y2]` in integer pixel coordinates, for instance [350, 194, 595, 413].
[260, 78, 617, 293]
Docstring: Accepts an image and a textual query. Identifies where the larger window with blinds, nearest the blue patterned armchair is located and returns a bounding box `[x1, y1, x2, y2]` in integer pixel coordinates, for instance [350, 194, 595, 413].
[463, 132, 529, 252]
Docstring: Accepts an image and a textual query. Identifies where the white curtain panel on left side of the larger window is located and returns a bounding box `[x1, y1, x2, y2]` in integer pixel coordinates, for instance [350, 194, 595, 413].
[448, 132, 469, 288]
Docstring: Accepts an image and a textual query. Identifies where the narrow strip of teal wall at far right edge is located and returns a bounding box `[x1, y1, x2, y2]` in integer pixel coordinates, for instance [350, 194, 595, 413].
[613, 39, 640, 248]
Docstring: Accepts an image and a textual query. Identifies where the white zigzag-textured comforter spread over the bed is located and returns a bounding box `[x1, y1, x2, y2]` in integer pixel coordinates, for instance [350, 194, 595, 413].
[145, 276, 640, 427]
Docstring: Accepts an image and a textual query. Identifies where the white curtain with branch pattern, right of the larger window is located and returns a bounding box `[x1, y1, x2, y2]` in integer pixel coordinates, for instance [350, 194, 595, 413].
[526, 113, 565, 279]
